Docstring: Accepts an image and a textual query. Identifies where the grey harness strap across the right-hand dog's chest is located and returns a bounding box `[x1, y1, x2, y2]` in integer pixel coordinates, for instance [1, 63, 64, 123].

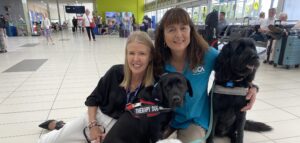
[213, 85, 248, 96]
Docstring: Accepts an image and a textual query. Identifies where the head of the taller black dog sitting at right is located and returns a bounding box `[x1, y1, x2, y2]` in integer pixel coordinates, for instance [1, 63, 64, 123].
[215, 38, 259, 82]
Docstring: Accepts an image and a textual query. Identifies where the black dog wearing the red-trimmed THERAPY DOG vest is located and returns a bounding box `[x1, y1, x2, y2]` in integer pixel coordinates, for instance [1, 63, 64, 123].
[104, 73, 192, 143]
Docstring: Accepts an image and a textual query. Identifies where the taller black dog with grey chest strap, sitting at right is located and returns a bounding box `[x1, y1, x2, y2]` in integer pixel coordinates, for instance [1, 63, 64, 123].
[207, 38, 271, 143]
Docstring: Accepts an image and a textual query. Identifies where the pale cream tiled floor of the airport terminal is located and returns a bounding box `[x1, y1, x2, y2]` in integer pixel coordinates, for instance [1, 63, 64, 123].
[0, 32, 300, 143]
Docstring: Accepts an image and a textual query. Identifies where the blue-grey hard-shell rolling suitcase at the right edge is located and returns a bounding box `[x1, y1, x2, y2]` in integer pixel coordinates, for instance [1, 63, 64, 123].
[273, 31, 300, 69]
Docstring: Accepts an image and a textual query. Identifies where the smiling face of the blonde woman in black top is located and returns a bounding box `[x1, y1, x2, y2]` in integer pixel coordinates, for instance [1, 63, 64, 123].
[126, 41, 151, 79]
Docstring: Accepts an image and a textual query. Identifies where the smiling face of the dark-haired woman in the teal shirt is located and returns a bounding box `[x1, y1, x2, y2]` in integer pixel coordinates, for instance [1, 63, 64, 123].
[164, 24, 191, 52]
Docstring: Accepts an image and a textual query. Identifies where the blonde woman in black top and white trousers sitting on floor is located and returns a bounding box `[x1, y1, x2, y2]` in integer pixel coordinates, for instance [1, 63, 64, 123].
[39, 31, 154, 143]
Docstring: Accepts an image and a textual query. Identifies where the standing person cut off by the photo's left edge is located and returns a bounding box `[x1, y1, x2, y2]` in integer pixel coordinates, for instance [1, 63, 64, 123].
[0, 14, 7, 53]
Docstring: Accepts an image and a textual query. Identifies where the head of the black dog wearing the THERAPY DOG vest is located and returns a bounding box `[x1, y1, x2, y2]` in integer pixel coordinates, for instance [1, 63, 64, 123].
[152, 73, 193, 108]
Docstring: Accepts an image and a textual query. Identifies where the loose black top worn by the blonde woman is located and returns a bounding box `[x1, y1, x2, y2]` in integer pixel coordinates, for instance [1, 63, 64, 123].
[85, 65, 143, 119]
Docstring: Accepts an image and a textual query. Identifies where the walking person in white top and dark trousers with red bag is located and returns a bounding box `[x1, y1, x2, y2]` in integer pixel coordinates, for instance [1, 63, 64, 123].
[82, 9, 96, 41]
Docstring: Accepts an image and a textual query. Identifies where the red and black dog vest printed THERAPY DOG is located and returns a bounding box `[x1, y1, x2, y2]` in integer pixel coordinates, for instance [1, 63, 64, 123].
[126, 99, 171, 118]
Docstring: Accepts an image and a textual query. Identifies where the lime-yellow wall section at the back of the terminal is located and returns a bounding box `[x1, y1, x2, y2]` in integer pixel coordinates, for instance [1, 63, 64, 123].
[96, 0, 144, 24]
